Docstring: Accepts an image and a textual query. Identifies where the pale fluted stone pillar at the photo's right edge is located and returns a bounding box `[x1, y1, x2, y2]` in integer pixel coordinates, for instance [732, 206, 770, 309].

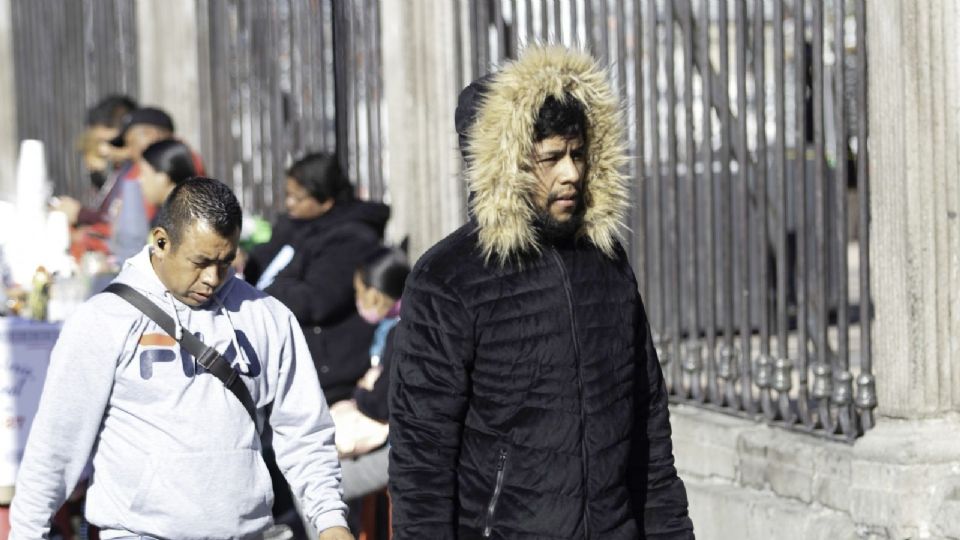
[866, 0, 960, 421]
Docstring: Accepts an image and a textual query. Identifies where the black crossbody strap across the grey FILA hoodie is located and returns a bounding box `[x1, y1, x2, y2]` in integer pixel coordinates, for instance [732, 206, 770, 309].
[104, 283, 260, 433]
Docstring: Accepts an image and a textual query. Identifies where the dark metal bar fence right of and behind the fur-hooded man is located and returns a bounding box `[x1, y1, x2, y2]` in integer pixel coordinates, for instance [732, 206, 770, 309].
[462, 0, 876, 440]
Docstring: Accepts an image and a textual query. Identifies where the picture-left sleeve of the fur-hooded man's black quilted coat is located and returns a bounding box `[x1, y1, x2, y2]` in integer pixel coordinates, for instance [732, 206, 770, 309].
[389, 269, 474, 540]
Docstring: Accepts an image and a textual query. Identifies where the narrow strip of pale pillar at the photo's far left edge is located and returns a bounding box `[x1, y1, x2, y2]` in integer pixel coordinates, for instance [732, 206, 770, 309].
[0, 0, 18, 200]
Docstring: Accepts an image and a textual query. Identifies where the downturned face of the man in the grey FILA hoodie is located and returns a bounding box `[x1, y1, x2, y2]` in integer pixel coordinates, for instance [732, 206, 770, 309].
[151, 220, 240, 306]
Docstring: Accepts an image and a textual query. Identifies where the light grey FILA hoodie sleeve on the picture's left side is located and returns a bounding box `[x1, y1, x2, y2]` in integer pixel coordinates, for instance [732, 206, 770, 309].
[10, 299, 138, 540]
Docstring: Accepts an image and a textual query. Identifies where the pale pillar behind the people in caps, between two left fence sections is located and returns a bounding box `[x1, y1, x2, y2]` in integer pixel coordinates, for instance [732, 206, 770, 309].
[137, 0, 201, 154]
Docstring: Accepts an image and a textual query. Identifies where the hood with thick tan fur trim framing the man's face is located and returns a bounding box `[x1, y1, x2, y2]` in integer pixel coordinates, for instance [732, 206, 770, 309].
[457, 46, 628, 264]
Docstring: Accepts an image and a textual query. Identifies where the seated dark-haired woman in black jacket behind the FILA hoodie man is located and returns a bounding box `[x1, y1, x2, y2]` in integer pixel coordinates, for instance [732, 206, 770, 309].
[244, 153, 390, 403]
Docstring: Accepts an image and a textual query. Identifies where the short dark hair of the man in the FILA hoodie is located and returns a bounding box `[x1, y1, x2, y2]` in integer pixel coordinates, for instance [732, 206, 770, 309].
[157, 176, 243, 246]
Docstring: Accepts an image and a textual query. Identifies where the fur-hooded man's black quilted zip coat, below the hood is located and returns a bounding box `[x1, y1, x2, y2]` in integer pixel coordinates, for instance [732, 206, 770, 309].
[390, 223, 693, 540]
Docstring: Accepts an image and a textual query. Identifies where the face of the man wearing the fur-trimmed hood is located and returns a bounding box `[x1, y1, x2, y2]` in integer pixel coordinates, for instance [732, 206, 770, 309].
[533, 135, 587, 224]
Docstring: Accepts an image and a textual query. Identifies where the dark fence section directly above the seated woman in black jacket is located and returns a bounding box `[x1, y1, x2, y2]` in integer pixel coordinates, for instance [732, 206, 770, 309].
[198, 0, 384, 215]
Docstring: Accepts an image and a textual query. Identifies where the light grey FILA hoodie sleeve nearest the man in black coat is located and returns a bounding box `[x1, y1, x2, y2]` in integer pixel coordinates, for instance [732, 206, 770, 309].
[270, 315, 347, 531]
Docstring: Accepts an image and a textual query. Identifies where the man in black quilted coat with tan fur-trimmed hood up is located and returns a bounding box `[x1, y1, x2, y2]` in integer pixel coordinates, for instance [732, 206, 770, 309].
[390, 47, 693, 540]
